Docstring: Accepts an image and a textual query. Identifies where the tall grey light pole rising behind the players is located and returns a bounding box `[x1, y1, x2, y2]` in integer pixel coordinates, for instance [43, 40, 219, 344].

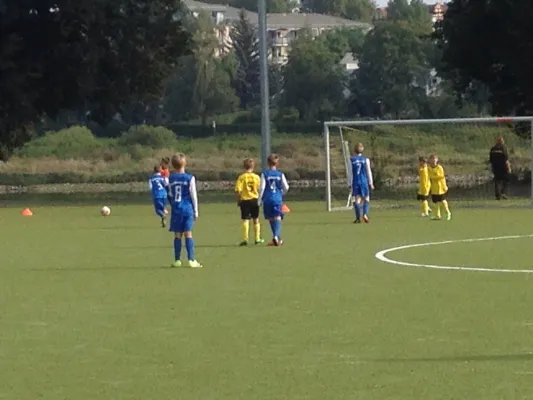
[257, 0, 270, 169]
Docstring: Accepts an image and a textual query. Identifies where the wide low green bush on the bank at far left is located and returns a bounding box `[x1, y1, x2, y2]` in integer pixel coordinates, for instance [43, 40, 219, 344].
[16, 126, 107, 160]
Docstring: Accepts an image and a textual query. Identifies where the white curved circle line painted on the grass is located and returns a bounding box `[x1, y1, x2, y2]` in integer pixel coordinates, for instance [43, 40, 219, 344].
[375, 234, 533, 274]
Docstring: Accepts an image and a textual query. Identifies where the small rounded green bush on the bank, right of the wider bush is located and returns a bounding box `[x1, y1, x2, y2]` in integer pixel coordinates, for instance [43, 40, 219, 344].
[118, 125, 178, 149]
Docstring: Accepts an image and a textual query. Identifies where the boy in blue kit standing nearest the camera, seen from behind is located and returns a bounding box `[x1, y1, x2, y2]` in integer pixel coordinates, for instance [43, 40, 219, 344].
[168, 153, 202, 268]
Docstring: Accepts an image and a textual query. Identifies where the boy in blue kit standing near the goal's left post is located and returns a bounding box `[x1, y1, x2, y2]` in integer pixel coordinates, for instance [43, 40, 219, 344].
[350, 143, 374, 224]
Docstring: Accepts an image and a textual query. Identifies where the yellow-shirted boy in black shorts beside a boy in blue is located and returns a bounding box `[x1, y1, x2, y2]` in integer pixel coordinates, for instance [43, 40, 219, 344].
[235, 158, 264, 246]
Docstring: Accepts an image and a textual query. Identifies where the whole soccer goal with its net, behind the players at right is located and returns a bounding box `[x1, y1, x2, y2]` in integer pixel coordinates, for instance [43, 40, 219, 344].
[324, 116, 533, 211]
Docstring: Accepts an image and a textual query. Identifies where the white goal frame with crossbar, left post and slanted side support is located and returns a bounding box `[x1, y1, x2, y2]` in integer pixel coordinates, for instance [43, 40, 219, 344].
[324, 116, 533, 211]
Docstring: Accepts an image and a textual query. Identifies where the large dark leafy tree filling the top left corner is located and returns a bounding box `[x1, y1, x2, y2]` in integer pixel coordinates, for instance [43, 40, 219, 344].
[0, 0, 188, 160]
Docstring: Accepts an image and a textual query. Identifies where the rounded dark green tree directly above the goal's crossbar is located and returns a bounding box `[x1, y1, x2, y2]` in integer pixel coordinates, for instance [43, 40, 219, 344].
[352, 22, 431, 118]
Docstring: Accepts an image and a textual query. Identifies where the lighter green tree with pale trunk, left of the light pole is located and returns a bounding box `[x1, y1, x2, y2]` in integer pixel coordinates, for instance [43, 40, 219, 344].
[165, 12, 239, 125]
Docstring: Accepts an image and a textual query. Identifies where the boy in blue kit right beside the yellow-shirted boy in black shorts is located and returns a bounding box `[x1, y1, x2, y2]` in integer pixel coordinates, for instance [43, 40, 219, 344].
[259, 154, 289, 246]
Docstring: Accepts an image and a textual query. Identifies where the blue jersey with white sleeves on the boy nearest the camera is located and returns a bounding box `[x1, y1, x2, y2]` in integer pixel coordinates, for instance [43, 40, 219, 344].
[168, 172, 198, 217]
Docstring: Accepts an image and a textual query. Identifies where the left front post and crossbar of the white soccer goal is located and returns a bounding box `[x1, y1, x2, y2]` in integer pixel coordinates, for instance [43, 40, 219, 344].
[324, 116, 533, 211]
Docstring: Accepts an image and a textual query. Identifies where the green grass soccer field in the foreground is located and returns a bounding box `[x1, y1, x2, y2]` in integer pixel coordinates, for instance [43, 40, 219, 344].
[0, 202, 533, 400]
